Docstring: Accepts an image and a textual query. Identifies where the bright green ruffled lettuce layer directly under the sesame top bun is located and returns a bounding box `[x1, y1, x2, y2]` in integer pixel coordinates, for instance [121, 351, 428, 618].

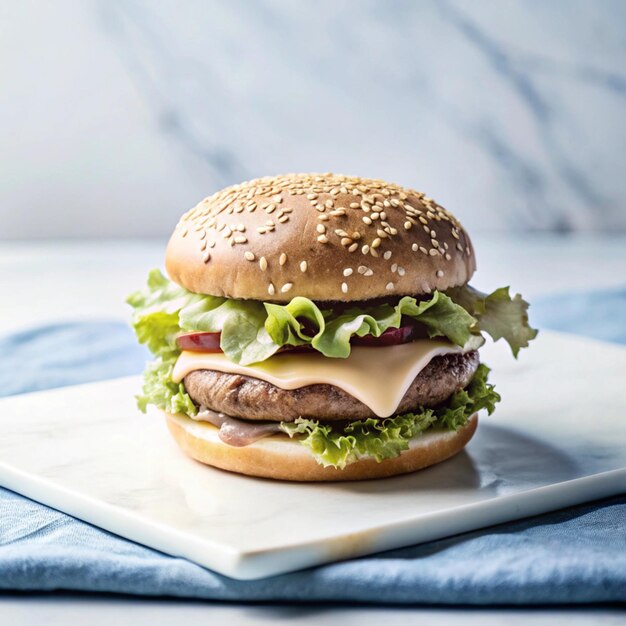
[127, 270, 486, 365]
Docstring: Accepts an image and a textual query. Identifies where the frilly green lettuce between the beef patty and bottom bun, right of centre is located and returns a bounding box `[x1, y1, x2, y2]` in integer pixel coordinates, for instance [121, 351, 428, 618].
[280, 364, 500, 469]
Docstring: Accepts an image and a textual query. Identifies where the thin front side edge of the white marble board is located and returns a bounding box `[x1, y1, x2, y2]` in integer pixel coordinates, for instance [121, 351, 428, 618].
[0, 463, 626, 580]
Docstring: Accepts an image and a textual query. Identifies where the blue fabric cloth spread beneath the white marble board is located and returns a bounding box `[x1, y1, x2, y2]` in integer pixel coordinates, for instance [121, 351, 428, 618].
[0, 290, 626, 604]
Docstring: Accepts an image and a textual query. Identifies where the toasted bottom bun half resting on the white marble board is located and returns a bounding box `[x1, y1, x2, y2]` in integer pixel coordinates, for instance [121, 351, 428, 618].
[165, 413, 478, 481]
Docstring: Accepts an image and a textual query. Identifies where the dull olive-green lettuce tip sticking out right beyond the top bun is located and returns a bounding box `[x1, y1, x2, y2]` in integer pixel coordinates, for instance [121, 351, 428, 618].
[447, 285, 538, 358]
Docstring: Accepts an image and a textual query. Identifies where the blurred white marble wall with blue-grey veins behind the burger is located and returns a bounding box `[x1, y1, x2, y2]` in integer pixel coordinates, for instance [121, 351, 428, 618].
[0, 0, 626, 239]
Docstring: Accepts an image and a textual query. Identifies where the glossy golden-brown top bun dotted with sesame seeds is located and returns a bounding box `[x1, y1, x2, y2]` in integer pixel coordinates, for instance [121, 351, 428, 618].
[165, 174, 476, 302]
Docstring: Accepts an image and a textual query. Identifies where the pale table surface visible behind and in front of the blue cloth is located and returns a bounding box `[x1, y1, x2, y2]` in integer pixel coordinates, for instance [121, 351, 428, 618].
[0, 234, 626, 626]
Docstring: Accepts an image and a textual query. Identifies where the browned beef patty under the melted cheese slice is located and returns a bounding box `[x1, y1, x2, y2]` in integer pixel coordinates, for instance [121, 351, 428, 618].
[184, 350, 479, 422]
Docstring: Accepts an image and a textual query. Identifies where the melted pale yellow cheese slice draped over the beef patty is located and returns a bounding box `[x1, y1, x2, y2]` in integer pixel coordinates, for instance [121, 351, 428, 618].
[173, 339, 477, 417]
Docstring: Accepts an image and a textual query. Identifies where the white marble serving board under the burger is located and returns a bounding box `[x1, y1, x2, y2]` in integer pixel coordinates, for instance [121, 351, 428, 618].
[0, 332, 626, 579]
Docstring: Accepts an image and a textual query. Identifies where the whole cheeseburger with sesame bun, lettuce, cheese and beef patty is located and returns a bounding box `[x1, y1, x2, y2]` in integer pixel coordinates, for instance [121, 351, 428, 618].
[128, 174, 537, 481]
